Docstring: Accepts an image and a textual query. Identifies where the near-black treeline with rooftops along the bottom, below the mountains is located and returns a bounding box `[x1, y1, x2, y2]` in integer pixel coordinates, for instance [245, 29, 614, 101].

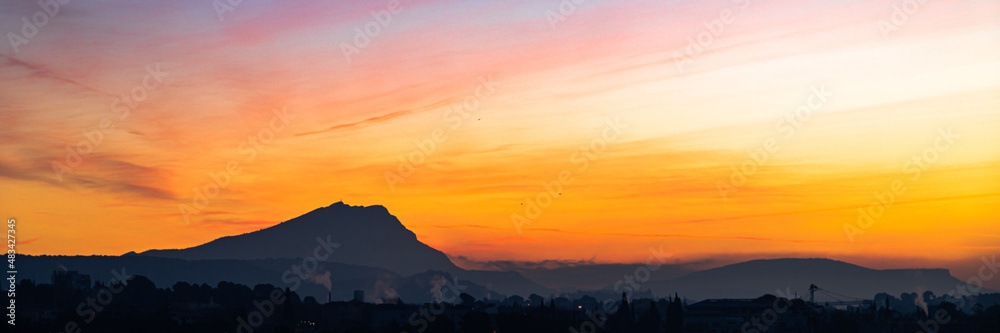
[16, 276, 1000, 333]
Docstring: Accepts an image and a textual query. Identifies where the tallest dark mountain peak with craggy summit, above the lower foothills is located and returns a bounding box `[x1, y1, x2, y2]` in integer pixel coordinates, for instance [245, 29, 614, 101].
[140, 202, 460, 276]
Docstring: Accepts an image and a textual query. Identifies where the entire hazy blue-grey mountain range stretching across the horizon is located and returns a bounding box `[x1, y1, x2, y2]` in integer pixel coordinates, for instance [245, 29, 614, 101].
[20, 202, 992, 302]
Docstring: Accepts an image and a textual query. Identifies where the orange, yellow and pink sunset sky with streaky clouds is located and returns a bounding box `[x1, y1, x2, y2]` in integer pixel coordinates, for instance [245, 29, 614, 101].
[0, 0, 1000, 289]
